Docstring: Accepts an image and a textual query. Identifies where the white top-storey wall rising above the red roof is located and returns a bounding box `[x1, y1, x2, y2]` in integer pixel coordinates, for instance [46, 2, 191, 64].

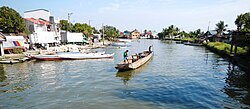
[24, 10, 50, 21]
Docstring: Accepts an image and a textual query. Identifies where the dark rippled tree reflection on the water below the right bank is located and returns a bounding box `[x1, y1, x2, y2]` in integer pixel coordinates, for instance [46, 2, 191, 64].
[224, 62, 250, 106]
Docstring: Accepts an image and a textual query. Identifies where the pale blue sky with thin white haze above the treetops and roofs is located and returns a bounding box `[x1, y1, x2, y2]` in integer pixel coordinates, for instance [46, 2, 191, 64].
[0, 0, 250, 32]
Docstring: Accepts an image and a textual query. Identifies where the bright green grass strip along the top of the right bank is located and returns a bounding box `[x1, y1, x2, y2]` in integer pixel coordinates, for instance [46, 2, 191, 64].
[207, 42, 248, 55]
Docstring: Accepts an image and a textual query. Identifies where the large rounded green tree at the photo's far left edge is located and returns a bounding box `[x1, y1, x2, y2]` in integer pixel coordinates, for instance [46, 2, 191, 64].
[0, 6, 25, 33]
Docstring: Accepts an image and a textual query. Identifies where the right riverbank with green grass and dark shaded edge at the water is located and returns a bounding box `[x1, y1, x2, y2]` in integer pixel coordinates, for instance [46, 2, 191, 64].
[205, 42, 250, 71]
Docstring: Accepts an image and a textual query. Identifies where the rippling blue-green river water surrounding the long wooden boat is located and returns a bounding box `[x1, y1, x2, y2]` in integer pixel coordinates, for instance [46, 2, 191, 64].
[0, 40, 250, 109]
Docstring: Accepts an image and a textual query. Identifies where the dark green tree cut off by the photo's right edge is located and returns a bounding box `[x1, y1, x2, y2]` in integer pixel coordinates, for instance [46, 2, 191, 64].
[234, 12, 250, 31]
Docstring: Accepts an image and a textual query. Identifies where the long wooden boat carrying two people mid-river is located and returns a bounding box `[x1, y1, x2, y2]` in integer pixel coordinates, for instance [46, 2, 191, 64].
[115, 51, 153, 71]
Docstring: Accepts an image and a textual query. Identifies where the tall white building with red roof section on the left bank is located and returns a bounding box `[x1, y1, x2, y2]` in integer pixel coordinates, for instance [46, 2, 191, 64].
[24, 9, 61, 45]
